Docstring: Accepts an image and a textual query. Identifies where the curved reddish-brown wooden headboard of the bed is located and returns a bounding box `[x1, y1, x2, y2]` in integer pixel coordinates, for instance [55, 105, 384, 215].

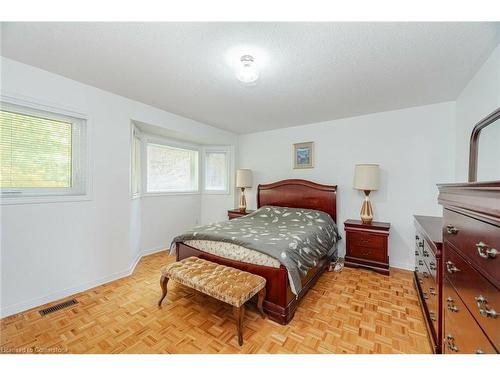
[257, 179, 337, 222]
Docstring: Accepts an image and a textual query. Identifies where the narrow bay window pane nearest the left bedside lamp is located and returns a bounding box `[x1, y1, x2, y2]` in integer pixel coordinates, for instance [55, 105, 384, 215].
[205, 150, 229, 193]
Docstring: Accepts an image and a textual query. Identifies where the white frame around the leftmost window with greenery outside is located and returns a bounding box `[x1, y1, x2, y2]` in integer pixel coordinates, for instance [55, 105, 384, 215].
[0, 95, 90, 205]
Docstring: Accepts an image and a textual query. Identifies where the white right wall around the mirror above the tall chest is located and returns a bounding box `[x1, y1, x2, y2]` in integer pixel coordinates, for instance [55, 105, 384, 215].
[455, 45, 500, 182]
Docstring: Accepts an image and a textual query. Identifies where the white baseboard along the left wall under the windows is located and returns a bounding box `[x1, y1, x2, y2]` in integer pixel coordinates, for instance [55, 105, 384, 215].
[0, 247, 167, 318]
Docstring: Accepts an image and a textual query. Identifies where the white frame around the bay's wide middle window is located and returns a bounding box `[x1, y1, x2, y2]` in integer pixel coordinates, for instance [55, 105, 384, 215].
[141, 135, 202, 197]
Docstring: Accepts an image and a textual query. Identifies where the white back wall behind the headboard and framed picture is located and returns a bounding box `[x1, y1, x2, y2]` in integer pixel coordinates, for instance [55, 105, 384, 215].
[238, 102, 455, 269]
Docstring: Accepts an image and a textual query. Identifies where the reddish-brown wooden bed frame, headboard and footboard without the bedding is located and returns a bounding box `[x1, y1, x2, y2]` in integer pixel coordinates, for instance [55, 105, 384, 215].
[175, 179, 337, 324]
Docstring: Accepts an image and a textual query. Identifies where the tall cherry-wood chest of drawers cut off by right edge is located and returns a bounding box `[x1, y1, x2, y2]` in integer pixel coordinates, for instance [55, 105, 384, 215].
[438, 181, 500, 354]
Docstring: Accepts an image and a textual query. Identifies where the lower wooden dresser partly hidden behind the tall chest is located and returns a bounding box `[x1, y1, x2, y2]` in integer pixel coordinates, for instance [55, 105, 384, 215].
[414, 215, 443, 353]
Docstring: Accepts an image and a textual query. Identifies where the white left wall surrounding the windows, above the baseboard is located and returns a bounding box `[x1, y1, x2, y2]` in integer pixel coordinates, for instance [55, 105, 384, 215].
[0, 58, 237, 316]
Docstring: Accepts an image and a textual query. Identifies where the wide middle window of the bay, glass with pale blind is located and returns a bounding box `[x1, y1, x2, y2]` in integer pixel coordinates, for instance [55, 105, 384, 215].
[146, 143, 198, 193]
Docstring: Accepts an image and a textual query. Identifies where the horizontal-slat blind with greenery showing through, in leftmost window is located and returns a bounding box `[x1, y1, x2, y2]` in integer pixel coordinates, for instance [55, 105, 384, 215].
[0, 110, 72, 189]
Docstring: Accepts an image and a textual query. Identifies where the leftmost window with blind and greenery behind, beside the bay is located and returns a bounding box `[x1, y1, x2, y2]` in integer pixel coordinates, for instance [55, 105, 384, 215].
[0, 99, 85, 199]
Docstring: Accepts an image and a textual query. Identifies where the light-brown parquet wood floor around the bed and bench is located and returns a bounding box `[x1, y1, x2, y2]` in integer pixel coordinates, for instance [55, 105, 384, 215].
[0, 252, 431, 353]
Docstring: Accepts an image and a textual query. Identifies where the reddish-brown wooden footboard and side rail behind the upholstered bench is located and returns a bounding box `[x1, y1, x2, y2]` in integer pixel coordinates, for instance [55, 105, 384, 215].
[176, 242, 329, 324]
